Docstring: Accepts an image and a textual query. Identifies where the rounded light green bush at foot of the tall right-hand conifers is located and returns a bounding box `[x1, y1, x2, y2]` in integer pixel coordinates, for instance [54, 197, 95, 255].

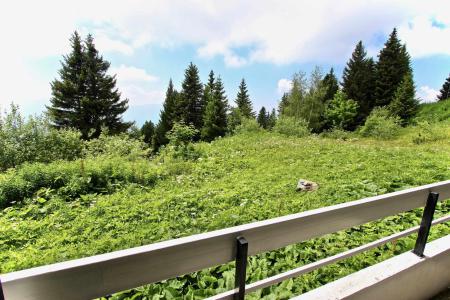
[359, 107, 400, 140]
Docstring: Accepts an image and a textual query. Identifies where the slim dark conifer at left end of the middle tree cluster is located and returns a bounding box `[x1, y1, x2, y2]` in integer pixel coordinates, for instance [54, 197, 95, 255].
[153, 79, 180, 151]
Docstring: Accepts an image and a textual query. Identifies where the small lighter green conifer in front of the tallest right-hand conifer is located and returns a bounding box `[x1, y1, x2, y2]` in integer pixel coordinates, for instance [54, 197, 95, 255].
[389, 74, 419, 125]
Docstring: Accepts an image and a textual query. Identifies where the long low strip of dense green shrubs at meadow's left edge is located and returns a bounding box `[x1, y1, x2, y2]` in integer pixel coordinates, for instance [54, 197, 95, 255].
[0, 156, 161, 207]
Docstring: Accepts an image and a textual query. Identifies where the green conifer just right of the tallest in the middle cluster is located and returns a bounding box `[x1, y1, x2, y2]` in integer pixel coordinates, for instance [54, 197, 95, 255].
[201, 77, 228, 142]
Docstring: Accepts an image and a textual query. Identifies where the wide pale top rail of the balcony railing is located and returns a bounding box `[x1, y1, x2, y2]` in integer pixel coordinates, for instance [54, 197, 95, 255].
[0, 180, 450, 300]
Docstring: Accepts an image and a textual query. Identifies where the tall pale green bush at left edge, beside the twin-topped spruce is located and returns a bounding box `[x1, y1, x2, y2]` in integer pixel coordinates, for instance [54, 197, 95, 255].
[0, 104, 83, 171]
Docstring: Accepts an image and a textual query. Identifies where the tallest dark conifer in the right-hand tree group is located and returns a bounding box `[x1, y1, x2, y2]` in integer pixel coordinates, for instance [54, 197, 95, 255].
[374, 28, 412, 106]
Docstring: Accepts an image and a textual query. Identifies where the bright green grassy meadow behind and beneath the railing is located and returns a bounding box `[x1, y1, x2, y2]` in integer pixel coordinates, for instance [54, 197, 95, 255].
[0, 127, 450, 299]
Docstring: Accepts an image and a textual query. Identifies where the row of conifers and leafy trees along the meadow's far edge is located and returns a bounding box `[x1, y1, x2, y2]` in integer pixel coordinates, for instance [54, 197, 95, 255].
[47, 28, 450, 151]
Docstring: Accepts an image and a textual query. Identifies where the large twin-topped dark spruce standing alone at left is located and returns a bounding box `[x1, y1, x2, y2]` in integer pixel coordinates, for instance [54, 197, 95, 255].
[47, 32, 133, 139]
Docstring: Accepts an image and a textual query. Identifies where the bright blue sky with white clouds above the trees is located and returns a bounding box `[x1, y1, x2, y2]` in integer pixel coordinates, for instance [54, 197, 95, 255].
[0, 0, 450, 125]
